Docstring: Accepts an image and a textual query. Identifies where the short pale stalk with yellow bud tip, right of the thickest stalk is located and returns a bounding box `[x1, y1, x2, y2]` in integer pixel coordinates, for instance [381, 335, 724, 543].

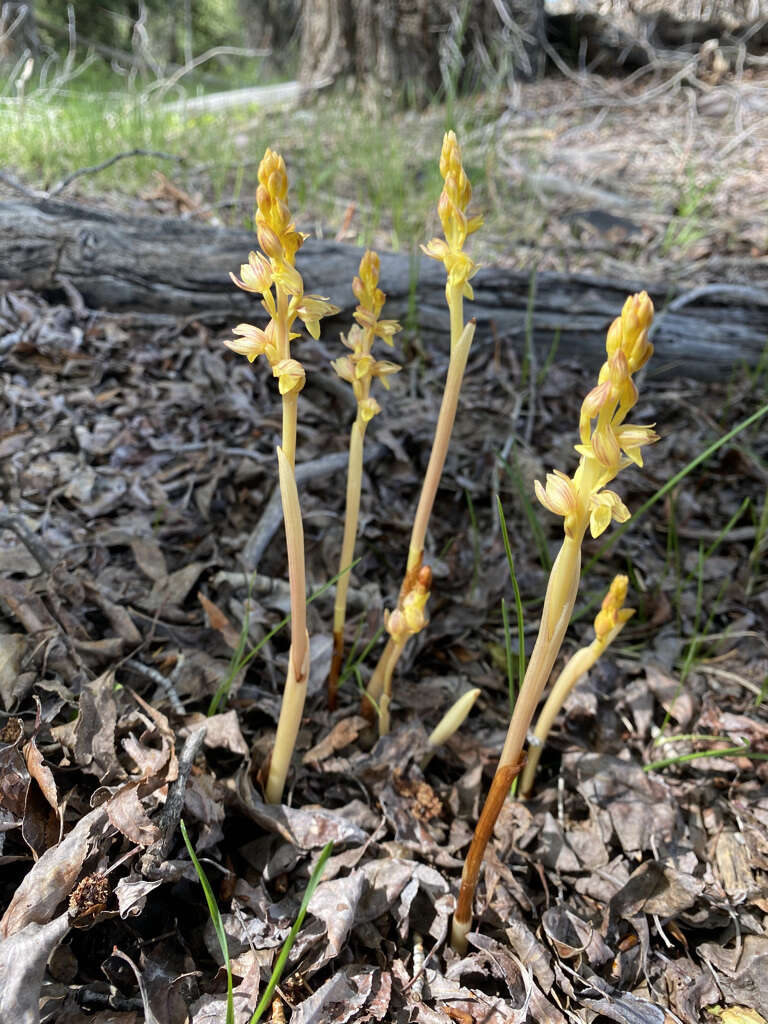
[519, 575, 635, 799]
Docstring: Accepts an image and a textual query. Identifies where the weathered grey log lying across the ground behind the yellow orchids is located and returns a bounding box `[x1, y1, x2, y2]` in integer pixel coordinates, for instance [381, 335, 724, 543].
[0, 200, 768, 379]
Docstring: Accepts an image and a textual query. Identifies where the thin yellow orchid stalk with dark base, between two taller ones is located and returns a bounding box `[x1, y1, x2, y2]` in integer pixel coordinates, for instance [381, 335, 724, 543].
[328, 250, 400, 710]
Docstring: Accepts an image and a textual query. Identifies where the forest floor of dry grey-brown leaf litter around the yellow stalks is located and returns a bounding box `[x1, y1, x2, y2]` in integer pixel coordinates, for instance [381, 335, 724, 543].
[0, 68, 768, 1024]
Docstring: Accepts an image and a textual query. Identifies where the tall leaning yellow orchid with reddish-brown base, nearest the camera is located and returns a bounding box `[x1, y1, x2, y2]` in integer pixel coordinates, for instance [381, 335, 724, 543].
[452, 292, 657, 952]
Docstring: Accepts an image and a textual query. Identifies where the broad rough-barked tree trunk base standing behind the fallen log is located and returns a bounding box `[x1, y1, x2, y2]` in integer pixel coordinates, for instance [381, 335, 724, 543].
[299, 0, 544, 103]
